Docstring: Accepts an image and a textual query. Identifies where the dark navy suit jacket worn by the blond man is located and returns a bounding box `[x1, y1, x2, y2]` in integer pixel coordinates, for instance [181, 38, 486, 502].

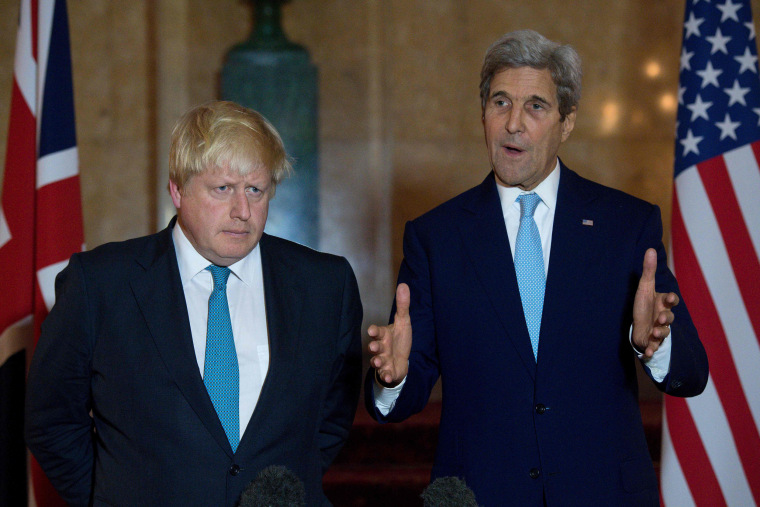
[26, 223, 362, 506]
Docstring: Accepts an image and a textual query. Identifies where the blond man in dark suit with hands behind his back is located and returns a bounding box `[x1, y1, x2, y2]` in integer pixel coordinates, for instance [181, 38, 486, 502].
[26, 102, 362, 506]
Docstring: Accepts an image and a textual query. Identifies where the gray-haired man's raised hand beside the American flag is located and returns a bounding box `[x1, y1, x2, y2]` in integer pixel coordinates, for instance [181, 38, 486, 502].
[632, 248, 679, 357]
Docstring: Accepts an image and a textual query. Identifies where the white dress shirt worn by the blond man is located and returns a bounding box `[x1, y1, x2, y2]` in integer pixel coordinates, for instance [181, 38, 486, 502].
[172, 224, 269, 438]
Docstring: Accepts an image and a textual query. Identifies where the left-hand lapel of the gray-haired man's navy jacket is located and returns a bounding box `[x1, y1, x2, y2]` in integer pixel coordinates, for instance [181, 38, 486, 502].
[459, 173, 536, 378]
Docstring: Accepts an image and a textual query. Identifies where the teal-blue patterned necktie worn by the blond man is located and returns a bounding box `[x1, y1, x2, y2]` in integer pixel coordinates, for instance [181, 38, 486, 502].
[203, 264, 240, 452]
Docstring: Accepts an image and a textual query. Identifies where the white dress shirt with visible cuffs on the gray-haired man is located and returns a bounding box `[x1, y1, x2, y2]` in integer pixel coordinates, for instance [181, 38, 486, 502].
[373, 159, 671, 415]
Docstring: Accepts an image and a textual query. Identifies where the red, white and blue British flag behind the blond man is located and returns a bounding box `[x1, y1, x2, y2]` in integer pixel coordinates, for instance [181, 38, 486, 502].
[0, 0, 84, 506]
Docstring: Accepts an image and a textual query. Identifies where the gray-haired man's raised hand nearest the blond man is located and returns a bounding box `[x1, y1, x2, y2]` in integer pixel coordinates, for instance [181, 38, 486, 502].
[367, 283, 412, 386]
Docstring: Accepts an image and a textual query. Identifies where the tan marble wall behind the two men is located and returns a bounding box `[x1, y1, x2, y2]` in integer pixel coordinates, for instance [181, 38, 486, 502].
[0, 0, 760, 396]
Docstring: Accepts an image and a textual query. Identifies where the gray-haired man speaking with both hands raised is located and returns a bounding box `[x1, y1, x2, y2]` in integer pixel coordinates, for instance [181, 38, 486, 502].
[365, 30, 708, 506]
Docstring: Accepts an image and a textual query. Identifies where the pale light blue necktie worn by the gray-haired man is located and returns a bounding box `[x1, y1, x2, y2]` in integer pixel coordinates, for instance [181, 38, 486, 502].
[515, 194, 546, 360]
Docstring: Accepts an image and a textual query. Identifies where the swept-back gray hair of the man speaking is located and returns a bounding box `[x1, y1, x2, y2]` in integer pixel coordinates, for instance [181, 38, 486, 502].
[480, 30, 582, 121]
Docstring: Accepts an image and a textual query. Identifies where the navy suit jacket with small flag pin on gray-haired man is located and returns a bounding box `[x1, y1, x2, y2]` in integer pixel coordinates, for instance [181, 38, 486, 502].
[366, 165, 708, 507]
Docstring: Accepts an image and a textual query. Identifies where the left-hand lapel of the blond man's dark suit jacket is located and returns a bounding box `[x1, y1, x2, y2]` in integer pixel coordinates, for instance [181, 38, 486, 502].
[131, 219, 232, 456]
